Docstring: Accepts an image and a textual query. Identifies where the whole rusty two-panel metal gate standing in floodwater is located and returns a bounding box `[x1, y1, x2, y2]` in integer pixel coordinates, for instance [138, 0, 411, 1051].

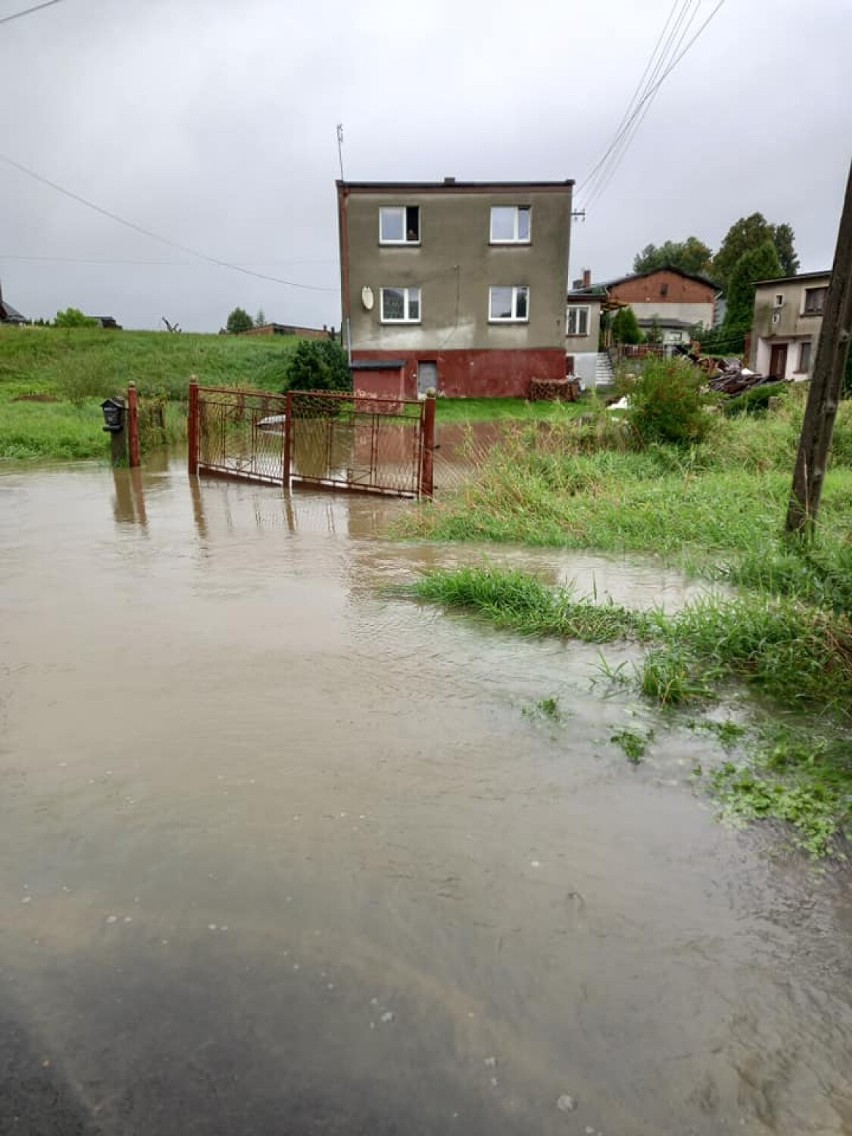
[187, 383, 435, 498]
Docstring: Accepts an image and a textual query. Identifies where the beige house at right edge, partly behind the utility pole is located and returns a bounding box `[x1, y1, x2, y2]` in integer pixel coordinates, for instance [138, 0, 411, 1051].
[751, 272, 832, 379]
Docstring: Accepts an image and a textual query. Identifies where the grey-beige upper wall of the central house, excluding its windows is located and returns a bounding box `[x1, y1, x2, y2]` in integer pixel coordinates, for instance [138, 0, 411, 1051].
[339, 184, 571, 354]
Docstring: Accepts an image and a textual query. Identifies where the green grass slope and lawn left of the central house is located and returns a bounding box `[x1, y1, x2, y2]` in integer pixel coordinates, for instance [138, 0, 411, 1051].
[0, 327, 299, 460]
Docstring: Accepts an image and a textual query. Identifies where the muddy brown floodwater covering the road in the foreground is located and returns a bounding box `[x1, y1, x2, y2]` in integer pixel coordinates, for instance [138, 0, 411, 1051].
[0, 456, 852, 1136]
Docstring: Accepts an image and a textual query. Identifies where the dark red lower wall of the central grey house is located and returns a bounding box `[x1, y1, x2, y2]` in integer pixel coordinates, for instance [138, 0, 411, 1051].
[352, 348, 566, 399]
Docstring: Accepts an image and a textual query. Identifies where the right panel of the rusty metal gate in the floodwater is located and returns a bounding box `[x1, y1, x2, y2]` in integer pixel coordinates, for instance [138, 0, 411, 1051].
[290, 391, 424, 496]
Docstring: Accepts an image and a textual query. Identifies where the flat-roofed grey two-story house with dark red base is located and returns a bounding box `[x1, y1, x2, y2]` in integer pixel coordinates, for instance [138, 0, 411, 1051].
[337, 178, 574, 398]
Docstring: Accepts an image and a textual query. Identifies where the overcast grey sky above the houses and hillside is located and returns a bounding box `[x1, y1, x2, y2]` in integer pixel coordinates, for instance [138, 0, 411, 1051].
[0, 0, 852, 331]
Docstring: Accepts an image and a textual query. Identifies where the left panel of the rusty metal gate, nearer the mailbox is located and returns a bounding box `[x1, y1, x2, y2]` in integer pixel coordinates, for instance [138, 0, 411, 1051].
[198, 386, 286, 485]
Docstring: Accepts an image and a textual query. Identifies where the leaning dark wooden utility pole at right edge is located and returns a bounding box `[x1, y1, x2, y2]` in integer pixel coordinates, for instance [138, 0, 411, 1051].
[786, 164, 852, 534]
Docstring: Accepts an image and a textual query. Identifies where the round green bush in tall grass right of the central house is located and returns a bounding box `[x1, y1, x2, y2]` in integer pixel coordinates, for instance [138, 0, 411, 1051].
[624, 358, 711, 445]
